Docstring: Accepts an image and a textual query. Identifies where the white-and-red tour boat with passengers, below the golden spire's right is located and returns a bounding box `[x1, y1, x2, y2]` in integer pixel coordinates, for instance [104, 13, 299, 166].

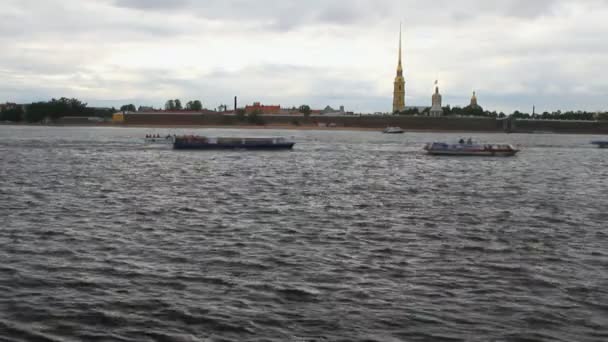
[424, 142, 519, 157]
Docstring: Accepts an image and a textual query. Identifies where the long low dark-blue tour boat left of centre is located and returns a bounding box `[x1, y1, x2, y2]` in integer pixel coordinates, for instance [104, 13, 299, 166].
[173, 135, 295, 150]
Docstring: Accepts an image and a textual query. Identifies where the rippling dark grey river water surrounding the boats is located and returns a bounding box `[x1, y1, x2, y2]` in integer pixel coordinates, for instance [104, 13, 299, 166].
[0, 126, 608, 341]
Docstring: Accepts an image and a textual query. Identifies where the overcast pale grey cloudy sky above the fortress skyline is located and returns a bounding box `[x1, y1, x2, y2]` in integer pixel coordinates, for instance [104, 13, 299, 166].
[0, 0, 608, 112]
